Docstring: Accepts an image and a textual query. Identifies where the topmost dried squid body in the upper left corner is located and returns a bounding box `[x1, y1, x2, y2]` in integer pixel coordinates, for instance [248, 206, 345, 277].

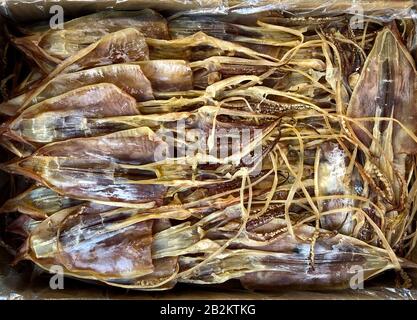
[14, 9, 169, 72]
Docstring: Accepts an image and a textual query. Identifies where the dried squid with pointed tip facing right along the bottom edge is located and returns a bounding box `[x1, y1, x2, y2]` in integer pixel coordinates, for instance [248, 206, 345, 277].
[180, 218, 394, 290]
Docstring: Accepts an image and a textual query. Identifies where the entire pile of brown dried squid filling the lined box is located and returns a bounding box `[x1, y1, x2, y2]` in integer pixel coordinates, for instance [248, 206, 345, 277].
[0, 10, 417, 290]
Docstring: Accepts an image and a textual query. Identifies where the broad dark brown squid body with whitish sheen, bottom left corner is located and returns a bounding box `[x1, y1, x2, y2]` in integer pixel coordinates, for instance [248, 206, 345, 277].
[24, 206, 153, 280]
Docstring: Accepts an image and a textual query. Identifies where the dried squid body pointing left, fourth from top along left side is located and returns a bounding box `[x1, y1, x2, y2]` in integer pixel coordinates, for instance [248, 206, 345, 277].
[9, 83, 139, 143]
